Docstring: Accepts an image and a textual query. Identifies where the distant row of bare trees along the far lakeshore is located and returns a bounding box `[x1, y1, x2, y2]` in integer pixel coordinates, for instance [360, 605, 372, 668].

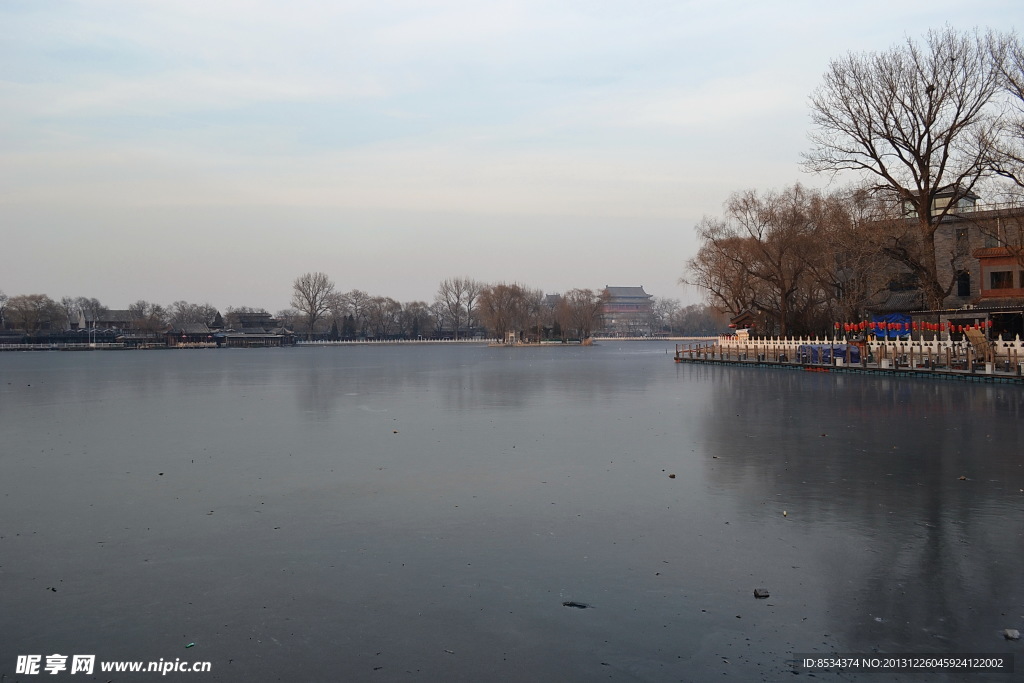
[0, 272, 725, 340]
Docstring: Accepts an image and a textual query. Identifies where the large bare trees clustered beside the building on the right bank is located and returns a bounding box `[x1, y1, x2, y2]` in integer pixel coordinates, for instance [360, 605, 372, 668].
[682, 27, 1024, 335]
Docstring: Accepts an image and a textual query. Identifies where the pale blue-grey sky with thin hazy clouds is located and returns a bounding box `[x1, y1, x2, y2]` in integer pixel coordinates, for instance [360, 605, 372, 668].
[0, 0, 1024, 312]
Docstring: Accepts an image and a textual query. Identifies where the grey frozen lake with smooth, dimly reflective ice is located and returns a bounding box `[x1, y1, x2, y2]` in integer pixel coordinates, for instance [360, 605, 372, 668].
[0, 342, 1024, 681]
